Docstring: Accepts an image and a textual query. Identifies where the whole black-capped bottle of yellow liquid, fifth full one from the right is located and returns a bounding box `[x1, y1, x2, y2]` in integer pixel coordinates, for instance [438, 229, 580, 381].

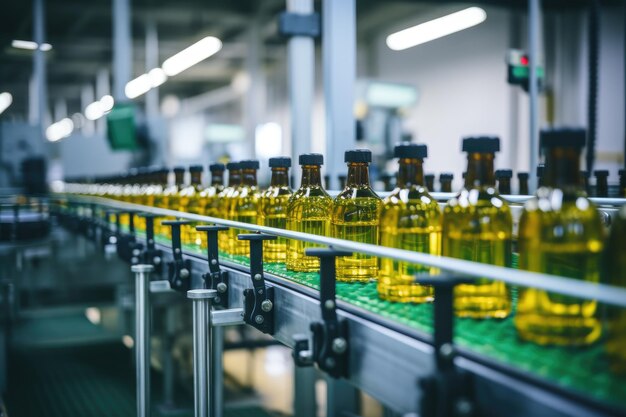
[287, 153, 333, 272]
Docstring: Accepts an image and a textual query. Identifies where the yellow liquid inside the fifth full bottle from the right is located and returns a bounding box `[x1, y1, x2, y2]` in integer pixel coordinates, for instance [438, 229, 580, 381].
[287, 187, 333, 272]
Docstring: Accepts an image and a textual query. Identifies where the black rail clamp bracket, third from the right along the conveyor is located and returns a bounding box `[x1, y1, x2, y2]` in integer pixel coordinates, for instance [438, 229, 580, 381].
[237, 233, 276, 334]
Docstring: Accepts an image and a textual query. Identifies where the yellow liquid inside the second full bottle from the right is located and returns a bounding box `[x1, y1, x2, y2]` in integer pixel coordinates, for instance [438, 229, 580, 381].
[442, 187, 513, 318]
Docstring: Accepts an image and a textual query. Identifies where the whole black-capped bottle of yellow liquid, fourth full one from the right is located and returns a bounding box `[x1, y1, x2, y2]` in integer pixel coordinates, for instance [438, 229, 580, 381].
[331, 149, 383, 282]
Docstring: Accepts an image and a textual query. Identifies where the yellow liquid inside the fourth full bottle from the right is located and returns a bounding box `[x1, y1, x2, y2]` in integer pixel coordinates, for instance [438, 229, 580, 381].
[331, 193, 382, 282]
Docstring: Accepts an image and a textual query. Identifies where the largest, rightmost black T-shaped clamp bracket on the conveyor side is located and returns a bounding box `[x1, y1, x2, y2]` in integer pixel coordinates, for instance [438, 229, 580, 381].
[416, 274, 477, 417]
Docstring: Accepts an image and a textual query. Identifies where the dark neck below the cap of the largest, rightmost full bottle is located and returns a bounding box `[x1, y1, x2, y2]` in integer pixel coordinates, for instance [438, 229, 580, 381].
[543, 147, 583, 189]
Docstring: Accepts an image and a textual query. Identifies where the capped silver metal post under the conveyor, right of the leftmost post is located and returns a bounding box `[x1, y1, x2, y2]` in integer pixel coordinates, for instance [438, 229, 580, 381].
[187, 289, 217, 417]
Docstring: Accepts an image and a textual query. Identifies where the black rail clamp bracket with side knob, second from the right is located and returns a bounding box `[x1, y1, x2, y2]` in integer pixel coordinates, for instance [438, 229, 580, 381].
[293, 248, 352, 378]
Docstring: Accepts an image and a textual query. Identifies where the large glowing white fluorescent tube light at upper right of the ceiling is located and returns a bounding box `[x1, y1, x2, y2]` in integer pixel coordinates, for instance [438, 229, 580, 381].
[387, 7, 487, 51]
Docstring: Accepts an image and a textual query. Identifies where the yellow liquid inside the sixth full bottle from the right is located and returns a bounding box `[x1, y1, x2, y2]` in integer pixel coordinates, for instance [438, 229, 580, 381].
[259, 186, 291, 262]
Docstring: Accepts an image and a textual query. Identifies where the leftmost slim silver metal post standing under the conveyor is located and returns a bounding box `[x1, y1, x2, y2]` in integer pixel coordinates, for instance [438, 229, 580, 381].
[131, 264, 154, 417]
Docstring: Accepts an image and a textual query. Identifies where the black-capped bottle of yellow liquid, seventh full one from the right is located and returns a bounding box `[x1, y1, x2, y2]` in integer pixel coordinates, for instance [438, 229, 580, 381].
[229, 160, 261, 256]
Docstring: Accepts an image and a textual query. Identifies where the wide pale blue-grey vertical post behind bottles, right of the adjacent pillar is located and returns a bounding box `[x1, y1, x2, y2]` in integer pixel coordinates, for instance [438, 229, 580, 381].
[322, 0, 356, 188]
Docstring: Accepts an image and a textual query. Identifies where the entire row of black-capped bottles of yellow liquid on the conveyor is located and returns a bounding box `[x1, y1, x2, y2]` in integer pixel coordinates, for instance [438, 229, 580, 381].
[59, 129, 626, 359]
